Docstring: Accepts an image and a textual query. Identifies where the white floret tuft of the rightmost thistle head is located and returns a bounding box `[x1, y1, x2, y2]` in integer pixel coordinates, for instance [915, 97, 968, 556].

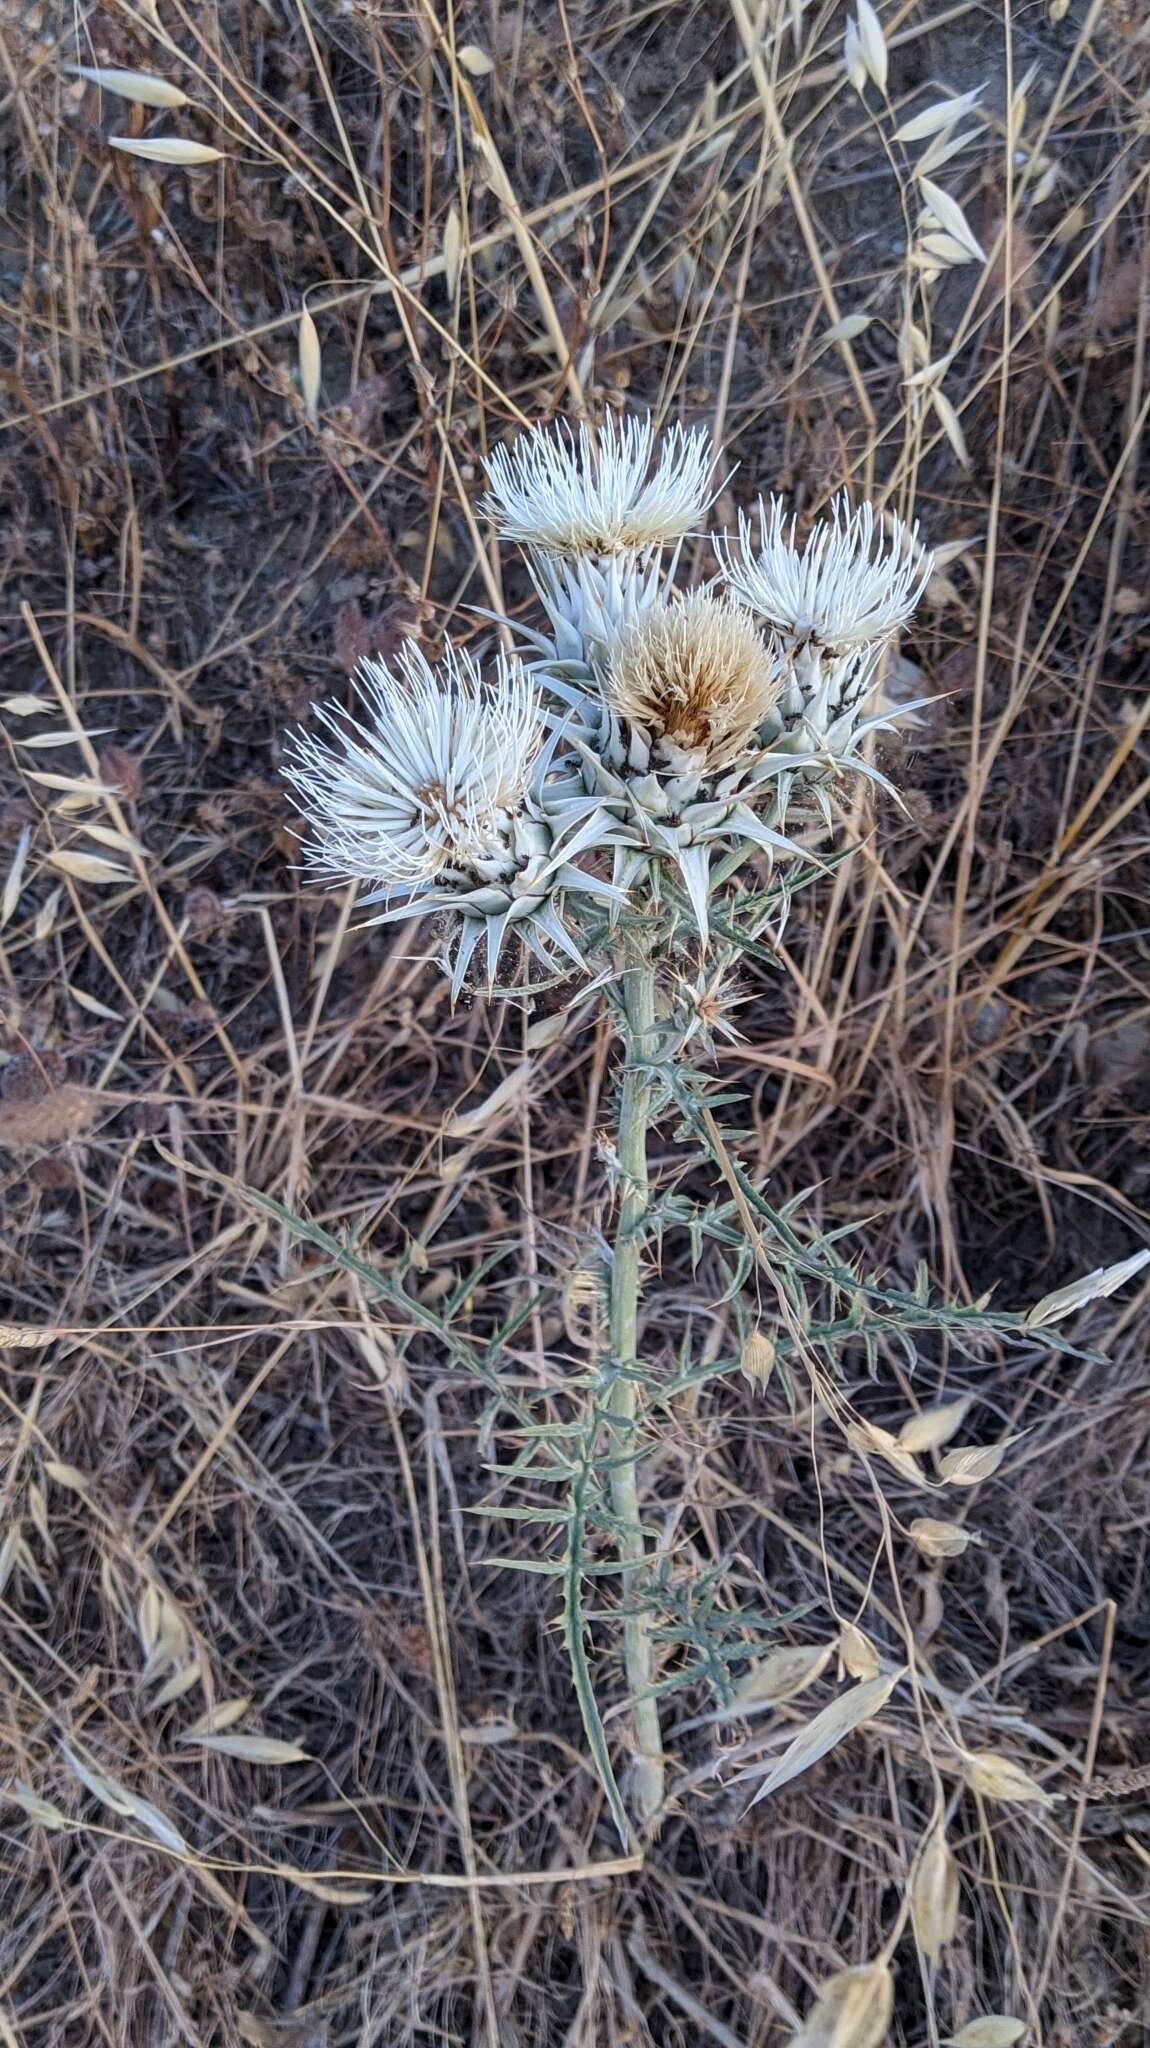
[714, 496, 933, 653]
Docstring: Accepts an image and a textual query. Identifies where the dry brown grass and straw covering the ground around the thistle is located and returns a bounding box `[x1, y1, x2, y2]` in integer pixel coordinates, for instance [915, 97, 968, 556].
[0, 0, 1150, 2048]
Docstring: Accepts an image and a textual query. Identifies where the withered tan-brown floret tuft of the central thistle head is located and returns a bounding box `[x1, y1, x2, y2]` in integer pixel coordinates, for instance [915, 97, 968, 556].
[606, 590, 780, 768]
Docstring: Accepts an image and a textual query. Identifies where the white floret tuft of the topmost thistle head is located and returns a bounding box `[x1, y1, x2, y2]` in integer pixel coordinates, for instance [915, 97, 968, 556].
[483, 414, 714, 555]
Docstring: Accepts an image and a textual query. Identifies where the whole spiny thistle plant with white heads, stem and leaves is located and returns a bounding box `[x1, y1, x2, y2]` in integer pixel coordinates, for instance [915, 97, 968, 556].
[286, 418, 1145, 1839]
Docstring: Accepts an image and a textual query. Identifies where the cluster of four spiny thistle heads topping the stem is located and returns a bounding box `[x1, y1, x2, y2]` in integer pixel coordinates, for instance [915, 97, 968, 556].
[286, 418, 933, 991]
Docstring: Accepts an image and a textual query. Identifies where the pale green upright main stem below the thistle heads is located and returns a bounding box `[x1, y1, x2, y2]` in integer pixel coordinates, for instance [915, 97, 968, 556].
[610, 958, 663, 1825]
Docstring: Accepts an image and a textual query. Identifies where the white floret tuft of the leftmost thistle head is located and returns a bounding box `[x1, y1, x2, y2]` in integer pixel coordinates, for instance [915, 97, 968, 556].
[284, 641, 544, 893]
